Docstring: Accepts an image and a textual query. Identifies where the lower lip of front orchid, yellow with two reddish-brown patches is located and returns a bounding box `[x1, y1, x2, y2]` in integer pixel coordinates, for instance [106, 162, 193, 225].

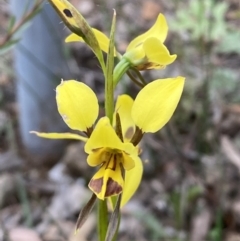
[88, 162, 123, 200]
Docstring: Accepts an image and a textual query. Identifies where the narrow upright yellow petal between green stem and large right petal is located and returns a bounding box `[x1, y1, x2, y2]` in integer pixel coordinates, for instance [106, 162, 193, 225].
[115, 95, 135, 141]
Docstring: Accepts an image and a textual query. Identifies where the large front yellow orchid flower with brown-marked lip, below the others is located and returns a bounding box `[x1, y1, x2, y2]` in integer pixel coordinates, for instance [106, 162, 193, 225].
[33, 77, 184, 206]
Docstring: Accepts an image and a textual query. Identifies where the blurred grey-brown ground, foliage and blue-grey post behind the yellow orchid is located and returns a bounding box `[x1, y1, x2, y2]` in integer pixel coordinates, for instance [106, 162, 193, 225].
[0, 0, 240, 241]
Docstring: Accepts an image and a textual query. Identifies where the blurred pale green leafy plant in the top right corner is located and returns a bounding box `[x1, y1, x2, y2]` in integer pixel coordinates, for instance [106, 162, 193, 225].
[170, 0, 240, 53]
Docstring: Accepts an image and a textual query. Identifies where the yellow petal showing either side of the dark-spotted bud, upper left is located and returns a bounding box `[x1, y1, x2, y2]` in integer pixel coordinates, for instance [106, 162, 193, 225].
[65, 28, 116, 56]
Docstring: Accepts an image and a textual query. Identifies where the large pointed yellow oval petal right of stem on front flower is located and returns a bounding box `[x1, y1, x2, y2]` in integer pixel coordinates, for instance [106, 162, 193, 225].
[132, 77, 185, 132]
